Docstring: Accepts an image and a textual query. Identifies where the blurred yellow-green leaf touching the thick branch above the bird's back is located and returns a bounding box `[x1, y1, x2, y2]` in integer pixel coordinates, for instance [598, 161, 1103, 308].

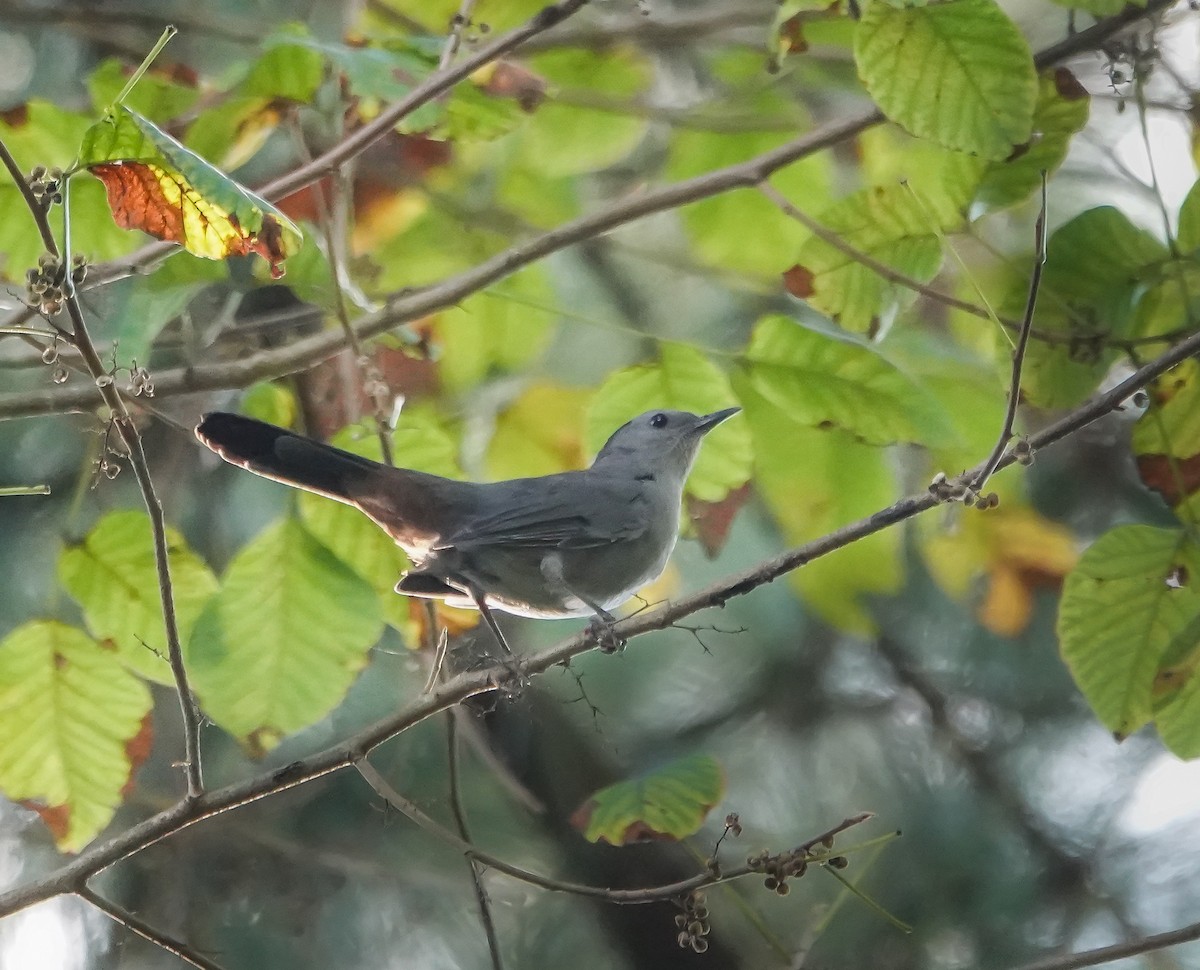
[436, 267, 559, 390]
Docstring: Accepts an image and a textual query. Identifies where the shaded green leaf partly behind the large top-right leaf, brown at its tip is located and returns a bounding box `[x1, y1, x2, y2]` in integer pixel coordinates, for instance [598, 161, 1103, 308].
[976, 67, 1091, 210]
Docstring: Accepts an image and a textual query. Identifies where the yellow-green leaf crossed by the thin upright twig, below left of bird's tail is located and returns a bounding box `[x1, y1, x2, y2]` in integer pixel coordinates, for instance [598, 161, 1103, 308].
[59, 510, 217, 684]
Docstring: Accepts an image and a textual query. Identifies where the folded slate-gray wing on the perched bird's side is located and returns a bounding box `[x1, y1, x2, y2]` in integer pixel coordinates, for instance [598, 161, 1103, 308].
[439, 475, 649, 551]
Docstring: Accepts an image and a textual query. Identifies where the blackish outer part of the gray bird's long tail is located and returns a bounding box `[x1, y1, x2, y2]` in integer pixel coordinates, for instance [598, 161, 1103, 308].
[196, 411, 380, 504]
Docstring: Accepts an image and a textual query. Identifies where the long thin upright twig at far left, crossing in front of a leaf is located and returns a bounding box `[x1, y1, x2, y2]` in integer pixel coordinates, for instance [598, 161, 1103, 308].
[0, 140, 204, 798]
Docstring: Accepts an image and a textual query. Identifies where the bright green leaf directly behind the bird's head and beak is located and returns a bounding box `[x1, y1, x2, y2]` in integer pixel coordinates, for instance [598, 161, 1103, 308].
[584, 341, 752, 502]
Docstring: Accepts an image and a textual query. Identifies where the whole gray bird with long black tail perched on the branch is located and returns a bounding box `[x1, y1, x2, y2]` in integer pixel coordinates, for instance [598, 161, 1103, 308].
[196, 407, 738, 649]
